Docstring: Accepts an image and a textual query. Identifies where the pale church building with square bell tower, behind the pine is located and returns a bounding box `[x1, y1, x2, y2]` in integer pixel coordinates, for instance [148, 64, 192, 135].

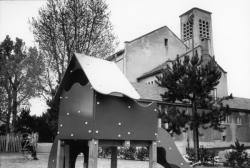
[106, 8, 250, 152]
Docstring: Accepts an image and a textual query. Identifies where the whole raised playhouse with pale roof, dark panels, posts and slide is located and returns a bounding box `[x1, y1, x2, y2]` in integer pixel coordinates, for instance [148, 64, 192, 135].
[48, 53, 190, 168]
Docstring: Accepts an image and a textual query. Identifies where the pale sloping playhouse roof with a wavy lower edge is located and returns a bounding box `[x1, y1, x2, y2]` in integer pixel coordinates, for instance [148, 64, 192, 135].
[75, 53, 140, 99]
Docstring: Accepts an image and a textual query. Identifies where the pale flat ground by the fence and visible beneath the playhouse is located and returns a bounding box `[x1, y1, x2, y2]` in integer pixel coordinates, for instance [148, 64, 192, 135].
[0, 153, 227, 168]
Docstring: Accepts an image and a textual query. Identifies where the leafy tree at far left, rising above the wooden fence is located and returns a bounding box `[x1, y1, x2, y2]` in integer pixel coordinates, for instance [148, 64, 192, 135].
[0, 35, 43, 132]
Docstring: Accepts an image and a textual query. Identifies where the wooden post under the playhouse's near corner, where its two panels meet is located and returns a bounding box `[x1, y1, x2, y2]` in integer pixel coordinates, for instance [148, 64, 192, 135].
[88, 139, 98, 168]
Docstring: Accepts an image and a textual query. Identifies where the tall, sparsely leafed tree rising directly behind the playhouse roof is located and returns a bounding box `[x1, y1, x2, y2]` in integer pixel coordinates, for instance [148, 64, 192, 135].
[31, 0, 116, 96]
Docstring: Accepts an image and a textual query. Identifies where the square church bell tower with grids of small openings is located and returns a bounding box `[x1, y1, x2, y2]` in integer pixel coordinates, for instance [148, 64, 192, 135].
[180, 8, 214, 56]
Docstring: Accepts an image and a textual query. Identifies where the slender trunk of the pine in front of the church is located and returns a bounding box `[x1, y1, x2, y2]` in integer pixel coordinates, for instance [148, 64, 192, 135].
[192, 102, 199, 161]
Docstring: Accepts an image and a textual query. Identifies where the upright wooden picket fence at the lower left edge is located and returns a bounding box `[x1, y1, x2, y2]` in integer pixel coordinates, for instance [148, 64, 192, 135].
[0, 134, 22, 152]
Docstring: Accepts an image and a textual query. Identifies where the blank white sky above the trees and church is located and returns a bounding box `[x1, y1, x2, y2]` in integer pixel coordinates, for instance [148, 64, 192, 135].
[0, 0, 250, 114]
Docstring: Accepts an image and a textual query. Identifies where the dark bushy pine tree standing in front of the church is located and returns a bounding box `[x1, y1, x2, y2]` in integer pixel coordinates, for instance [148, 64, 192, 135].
[157, 53, 229, 161]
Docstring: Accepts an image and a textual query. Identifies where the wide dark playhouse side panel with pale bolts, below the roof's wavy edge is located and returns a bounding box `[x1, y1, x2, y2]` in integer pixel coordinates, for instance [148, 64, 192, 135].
[94, 94, 157, 140]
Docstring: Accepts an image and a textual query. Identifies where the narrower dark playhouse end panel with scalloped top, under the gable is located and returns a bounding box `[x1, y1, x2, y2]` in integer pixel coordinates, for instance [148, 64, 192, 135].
[58, 83, 93, 139]
